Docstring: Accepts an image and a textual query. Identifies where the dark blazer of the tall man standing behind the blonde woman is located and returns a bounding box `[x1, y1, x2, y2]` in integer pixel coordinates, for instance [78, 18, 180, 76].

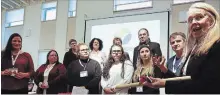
[133, 42, 162, 70]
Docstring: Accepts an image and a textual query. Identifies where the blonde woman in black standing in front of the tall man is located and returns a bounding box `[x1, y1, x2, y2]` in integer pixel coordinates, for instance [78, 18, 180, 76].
[131, 45, 162, 94]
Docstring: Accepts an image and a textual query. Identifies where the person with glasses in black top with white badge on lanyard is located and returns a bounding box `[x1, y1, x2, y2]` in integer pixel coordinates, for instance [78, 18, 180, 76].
[67, 43, 101, 94]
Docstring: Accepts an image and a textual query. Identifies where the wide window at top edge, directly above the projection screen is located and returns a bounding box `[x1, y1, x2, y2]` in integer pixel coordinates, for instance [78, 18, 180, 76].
[114, 0, 152, 11]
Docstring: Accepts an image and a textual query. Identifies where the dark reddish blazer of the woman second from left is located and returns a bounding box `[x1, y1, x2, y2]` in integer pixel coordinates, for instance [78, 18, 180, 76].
[34, 63, 66, 94]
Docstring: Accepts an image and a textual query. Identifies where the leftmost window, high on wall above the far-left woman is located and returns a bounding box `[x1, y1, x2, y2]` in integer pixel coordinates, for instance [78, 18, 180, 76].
[5, 8, 24, 27]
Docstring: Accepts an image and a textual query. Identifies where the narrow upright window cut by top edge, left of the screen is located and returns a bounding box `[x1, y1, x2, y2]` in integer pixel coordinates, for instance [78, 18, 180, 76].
[68, 0, 76, 17]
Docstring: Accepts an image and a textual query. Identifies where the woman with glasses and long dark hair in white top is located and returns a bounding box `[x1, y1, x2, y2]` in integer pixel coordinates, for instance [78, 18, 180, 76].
[101, 45, 134, 94]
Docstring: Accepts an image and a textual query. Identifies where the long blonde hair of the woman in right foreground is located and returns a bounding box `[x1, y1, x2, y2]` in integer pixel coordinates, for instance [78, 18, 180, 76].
[185, 2, 220, 56]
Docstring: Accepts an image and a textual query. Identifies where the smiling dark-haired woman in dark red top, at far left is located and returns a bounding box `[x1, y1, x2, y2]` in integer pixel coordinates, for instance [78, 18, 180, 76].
[1, 33, 34, 94]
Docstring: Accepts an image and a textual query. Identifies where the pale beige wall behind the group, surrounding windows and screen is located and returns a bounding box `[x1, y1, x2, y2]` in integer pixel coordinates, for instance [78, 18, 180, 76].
[1, 0, 220, 69]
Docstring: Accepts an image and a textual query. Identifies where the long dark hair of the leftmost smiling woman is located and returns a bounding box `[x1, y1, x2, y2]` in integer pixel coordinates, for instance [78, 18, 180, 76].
[3, 33, 22, 60]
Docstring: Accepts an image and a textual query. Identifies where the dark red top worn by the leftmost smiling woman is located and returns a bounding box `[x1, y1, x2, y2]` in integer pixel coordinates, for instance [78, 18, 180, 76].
[1, 52, 34, 90]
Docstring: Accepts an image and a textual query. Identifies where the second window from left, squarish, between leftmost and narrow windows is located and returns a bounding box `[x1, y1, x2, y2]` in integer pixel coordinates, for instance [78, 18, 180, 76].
[41, 2, 57, 21]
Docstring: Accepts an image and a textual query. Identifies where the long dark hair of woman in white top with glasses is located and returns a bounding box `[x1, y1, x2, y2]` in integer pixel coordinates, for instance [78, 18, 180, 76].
[103, 45, 126, 79]
